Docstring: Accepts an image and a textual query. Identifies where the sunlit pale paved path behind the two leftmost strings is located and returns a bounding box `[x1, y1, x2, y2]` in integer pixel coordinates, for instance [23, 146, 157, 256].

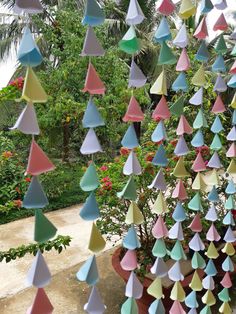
[0, 205, 115, 298]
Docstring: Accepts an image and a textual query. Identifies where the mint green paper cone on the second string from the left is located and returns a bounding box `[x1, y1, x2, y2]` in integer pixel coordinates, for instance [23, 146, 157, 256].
[80, 162, 99, 192]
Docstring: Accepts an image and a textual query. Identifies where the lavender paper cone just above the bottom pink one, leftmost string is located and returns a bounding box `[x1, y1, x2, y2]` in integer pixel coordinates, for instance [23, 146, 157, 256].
[27, 250, 51, 288]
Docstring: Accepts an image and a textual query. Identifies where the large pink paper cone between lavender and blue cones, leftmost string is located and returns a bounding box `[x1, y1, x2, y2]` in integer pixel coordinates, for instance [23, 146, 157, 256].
[26, 140, 55, 176]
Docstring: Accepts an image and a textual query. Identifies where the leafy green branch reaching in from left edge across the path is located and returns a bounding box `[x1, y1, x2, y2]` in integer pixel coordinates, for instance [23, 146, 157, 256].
[0, 235, 72, 263]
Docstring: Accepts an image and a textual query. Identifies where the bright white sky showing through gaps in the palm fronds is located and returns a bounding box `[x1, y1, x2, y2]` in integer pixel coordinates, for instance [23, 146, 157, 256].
[0, 0, 236, 89]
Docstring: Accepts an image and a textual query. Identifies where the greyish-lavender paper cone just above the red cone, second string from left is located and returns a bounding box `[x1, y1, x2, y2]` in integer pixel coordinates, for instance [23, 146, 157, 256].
[81, 26, 105, 57]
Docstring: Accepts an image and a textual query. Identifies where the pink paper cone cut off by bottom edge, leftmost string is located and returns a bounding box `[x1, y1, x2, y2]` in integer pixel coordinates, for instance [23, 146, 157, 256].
[26, 288, 54, 314]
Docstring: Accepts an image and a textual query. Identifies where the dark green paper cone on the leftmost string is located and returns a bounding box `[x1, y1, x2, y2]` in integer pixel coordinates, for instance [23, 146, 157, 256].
[34, 209, 57, 242]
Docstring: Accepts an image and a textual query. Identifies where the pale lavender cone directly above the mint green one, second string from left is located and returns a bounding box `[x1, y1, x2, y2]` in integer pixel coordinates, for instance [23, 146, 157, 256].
[80, 128, 103, 155]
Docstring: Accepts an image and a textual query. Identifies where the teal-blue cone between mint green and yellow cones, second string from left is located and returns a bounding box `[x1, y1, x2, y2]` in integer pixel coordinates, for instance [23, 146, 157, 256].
[79, 192, 100, 221]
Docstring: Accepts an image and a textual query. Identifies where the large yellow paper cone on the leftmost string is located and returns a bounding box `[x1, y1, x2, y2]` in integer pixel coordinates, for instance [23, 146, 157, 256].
[21, 67, 48, 103]
